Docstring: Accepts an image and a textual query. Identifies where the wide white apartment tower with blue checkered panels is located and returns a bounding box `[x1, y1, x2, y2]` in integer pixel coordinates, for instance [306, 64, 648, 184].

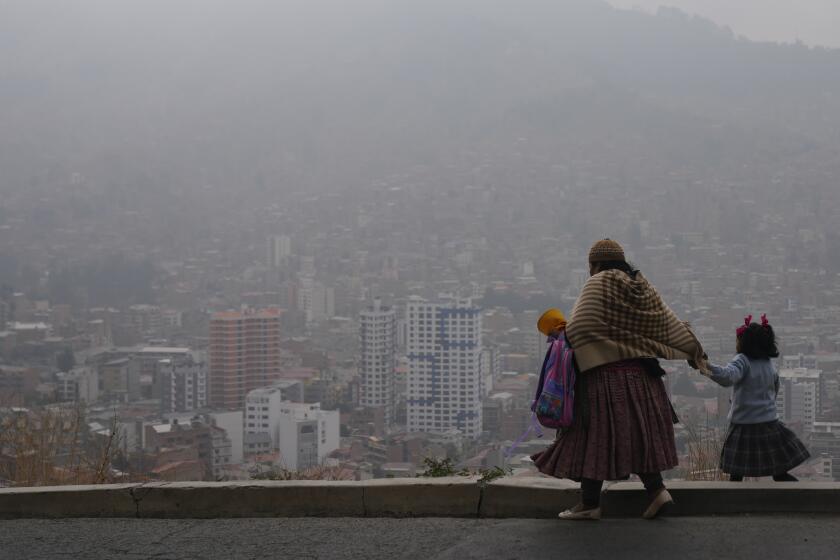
[406, 297, 482, 438]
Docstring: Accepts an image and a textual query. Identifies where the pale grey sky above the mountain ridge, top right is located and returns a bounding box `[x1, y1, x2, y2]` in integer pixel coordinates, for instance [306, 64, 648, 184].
[607, 0, 840, 48]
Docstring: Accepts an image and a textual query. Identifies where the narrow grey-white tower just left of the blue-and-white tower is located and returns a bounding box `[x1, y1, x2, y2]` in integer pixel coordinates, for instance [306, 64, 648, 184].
[359, 299, 397, 426]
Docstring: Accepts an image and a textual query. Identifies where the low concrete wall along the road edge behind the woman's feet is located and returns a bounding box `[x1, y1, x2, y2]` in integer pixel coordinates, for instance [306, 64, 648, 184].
[0, 477, 840, 519]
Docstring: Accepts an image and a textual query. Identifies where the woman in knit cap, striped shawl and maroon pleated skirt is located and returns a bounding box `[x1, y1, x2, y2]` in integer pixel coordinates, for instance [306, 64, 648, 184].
[532, 239, 707, 520]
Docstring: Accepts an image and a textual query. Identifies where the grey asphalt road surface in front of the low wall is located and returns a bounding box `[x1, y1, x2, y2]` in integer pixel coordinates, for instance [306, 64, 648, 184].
[0, 516, 840, 560]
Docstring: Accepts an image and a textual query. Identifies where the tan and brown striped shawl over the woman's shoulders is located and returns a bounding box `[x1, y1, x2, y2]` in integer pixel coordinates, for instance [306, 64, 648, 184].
[566, 270, 708, 373]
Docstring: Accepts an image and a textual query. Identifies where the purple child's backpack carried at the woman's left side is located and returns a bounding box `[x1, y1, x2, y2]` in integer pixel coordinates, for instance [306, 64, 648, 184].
[531, 334, 575, 429]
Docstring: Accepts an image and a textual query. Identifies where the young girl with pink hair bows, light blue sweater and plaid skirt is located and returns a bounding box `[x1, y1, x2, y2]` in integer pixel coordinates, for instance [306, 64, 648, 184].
[709, 315, 810, 482]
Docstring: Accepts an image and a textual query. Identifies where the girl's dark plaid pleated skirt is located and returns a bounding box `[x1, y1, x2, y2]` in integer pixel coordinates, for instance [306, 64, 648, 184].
[720, 420, 811, 476]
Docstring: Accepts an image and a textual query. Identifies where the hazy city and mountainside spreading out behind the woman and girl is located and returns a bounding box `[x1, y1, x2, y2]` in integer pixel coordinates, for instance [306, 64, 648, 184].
[0, 0, 840, 486]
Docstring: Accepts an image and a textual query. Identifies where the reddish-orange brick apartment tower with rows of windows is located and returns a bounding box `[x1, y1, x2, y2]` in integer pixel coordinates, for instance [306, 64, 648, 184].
[209, 308, 280, 409]
